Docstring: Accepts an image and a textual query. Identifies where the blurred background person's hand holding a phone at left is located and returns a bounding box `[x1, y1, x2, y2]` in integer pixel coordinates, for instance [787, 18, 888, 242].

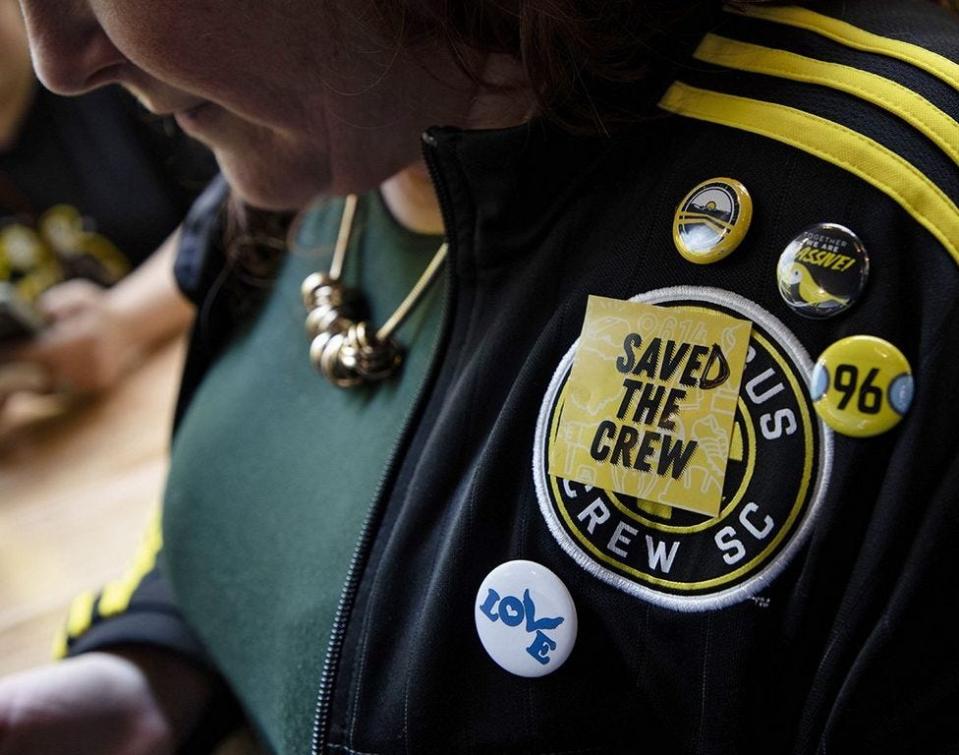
[0, 280, 138, 400]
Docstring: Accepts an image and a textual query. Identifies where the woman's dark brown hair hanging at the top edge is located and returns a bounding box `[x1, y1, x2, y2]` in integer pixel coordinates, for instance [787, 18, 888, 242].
[372, 0, 959, 132]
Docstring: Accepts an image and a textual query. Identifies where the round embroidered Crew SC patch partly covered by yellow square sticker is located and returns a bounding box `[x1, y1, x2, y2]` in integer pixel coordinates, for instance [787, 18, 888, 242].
[533, 286, 832, 611]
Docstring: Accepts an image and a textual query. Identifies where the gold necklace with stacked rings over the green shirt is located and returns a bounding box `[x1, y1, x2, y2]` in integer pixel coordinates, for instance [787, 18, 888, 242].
[289, 194, 447, 388]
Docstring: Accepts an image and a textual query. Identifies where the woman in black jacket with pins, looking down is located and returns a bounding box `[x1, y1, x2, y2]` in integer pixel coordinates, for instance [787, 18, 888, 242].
[0, 0, 959, 752]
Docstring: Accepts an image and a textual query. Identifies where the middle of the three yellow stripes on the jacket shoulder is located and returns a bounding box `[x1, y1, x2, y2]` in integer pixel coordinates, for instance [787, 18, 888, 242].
[695, 34, 959, 164]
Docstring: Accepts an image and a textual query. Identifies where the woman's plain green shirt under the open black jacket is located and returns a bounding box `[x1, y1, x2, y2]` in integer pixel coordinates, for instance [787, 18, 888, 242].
[164, 194, 445, 753]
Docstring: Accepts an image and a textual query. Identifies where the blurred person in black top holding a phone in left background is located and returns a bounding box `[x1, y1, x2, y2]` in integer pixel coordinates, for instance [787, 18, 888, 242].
[0, 0, 215, 405]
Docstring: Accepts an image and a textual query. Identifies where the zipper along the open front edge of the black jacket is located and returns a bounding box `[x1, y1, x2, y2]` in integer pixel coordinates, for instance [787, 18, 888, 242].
[310, 132, 456, 755]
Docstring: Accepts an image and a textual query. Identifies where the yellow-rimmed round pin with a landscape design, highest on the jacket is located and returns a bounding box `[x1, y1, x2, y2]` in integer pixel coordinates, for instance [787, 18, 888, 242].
[673, 178, 753, 265]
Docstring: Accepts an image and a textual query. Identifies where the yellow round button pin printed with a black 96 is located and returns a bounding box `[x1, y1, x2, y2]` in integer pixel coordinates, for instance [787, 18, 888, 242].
[810, 336, 915, 438]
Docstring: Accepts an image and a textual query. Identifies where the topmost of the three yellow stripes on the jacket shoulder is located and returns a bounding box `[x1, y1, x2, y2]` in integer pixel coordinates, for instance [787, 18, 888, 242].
[726, 5, 959, 89]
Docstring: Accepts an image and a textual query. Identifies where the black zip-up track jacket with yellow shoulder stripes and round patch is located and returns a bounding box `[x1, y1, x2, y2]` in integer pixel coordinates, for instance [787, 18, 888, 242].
[63, 1, 959, 753]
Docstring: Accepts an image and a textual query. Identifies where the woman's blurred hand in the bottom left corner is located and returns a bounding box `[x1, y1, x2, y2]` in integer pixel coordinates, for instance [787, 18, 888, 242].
[0, 648, 212, 755]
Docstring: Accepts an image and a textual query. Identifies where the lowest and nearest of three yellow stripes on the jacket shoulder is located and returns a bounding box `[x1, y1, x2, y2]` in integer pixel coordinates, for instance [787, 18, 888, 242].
[659, 82, 959, 263]
